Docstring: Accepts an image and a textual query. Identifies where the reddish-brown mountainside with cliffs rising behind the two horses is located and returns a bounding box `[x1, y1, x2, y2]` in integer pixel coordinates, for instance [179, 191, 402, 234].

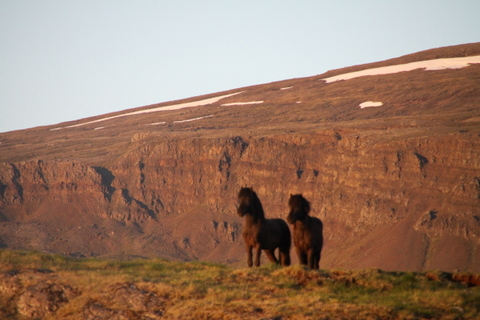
[0, 43, 480, 272]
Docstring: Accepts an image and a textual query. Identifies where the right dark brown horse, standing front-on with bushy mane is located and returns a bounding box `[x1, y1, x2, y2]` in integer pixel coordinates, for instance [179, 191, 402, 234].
[287, 194, 323, 269]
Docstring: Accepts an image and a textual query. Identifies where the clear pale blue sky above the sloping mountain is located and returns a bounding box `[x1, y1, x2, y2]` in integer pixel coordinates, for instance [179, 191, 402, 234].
[0, 0, 480, 132]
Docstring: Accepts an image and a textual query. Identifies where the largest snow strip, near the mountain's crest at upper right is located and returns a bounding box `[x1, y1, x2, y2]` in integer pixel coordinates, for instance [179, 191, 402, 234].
[322, 56, 480, 83]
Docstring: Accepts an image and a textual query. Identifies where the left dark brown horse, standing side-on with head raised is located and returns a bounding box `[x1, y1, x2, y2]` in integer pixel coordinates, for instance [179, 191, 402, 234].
[237, 188, 292, 267]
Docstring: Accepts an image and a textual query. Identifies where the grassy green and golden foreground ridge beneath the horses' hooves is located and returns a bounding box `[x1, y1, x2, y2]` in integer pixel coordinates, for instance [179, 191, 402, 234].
[0, 250, 480, 319]
